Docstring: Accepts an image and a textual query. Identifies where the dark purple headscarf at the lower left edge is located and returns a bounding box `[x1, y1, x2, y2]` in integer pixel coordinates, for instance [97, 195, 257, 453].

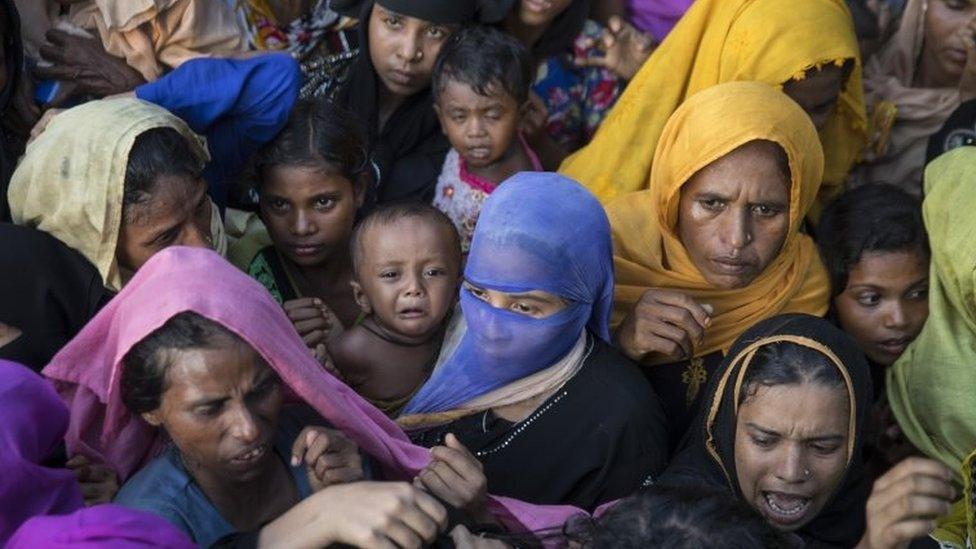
[0, 360, 83, 546]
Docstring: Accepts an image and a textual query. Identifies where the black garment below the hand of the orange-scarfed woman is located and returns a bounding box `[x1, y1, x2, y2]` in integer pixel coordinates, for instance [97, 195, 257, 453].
[641, 351, 722, 453]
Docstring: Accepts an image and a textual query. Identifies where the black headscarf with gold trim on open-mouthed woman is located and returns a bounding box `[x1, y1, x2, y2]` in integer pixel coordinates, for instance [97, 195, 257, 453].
[659, 314, 872, 547]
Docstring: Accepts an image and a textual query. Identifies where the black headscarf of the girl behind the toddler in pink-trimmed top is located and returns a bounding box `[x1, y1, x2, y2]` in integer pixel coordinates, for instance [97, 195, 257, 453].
[338, 0, 504, 202]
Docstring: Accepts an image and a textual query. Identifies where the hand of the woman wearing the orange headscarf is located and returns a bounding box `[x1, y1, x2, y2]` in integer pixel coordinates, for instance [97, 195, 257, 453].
[615, 290, 713, 363]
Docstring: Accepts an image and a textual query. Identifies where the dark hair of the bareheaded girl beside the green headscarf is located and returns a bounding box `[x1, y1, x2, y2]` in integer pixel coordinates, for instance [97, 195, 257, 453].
[817, 184, 931, 297]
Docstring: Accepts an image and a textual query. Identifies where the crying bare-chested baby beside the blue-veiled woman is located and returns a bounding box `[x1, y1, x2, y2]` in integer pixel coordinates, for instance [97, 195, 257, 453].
[329, 203, 461, 417]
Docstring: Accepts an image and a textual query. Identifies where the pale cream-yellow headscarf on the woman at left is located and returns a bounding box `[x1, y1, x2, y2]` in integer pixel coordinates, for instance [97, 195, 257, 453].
[7, 99, 226, 291]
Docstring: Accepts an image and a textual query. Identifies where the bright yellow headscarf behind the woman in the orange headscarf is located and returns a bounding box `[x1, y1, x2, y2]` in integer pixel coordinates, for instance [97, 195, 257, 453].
[559, 0, 867, 211]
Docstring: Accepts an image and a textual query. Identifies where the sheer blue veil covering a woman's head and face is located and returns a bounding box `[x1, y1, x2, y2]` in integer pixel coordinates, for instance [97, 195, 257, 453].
[403, 172, 613, 415]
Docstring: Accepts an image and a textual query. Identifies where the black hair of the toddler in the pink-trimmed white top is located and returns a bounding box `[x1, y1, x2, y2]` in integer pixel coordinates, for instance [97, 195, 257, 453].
[431, 25, 533, 105]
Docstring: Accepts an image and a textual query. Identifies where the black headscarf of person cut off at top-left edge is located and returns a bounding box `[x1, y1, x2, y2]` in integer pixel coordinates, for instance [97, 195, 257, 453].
[0, 0, 24, 221]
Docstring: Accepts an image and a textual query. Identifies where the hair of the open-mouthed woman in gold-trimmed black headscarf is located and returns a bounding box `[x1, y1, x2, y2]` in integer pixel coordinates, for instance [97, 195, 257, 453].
[737, 341, 844, 404]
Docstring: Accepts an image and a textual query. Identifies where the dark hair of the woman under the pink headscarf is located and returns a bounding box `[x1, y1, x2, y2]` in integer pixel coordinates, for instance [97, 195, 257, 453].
[119, 311, 243, 414]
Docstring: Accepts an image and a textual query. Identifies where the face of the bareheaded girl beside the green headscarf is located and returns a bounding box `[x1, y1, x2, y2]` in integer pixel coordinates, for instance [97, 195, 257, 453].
[834, 250, 929, 366]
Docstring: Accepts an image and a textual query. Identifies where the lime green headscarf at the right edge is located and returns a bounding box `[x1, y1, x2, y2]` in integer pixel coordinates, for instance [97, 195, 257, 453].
[887, 147, 976, 482]
